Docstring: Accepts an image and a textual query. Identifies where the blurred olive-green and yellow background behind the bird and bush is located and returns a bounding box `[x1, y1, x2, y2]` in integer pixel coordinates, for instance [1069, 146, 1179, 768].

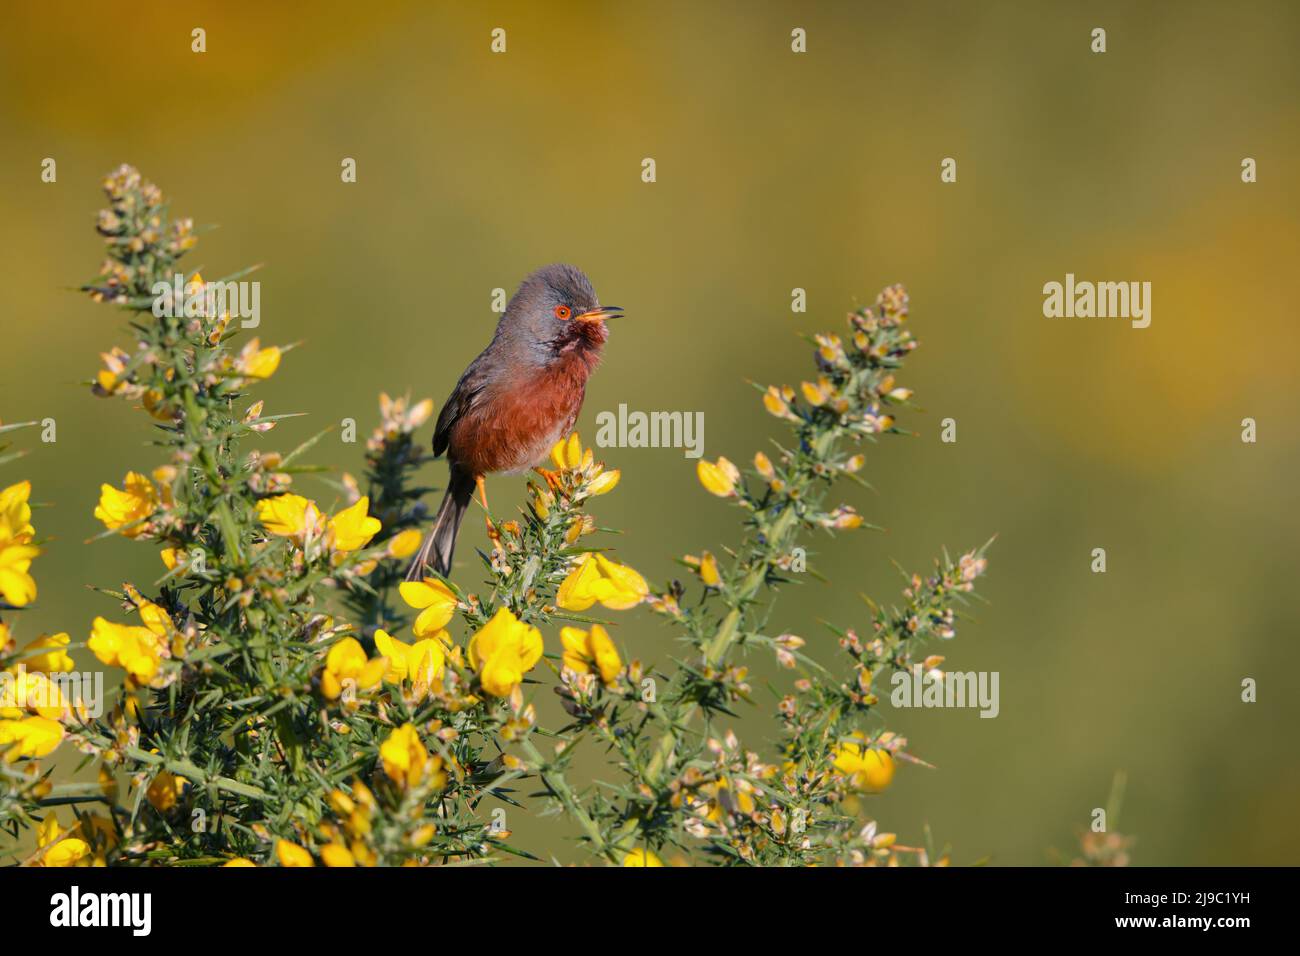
[0, 0, 1300, 864]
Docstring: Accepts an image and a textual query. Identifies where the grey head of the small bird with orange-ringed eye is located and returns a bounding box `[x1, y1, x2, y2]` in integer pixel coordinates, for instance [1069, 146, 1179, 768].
[501, 264, 623, 362]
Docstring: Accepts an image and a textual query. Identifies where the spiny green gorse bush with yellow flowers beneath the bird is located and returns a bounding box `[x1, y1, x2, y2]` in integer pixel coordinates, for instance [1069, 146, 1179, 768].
[0, 166, 985, 866]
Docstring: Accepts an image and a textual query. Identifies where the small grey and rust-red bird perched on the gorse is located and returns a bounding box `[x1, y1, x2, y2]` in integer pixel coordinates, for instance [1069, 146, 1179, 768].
[407, 264, 623, 581]
